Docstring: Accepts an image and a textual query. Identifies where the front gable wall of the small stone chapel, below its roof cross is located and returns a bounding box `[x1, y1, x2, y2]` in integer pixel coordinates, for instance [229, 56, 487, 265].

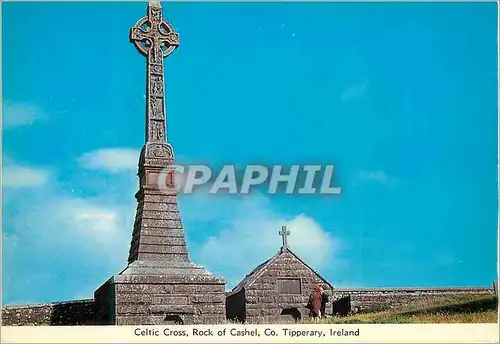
[245, 252, 332, 323]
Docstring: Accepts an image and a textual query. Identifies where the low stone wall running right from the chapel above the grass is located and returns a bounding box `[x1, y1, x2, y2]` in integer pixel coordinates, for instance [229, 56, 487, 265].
[333, 287, 495, 314]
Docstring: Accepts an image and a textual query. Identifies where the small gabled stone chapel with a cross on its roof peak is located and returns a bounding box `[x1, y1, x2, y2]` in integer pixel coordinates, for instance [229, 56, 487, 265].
[226, 227, 333, 323]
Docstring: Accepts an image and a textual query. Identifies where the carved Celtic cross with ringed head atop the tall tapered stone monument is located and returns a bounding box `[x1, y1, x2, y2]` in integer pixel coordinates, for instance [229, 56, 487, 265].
[130, 1, 179, 143]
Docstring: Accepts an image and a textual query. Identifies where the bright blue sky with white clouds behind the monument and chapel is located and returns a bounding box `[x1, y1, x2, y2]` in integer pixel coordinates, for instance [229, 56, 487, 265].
[2, 2, 498, 303]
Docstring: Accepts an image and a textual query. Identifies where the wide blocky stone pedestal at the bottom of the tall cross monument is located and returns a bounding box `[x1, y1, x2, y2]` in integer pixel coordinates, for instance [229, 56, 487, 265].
[94, 261, 226, 325]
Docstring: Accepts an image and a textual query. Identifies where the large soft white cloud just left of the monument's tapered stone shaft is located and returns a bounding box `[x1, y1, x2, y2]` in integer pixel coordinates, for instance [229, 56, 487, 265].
[8, 196, 135, 266]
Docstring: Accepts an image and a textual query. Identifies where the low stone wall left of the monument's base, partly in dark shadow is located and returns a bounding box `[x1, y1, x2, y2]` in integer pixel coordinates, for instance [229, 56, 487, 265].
[2, 299, 95, 326]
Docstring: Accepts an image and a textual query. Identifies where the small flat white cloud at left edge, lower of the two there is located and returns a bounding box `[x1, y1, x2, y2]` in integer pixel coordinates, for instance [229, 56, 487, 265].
[2, 164, 50, 188]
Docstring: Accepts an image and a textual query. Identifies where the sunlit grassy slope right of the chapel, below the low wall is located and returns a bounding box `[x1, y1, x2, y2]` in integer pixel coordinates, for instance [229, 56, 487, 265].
[317, 295, 498, 324]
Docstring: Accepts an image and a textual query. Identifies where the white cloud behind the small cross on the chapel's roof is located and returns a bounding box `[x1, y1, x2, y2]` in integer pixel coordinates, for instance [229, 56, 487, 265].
[193, 195, 340, 287]
